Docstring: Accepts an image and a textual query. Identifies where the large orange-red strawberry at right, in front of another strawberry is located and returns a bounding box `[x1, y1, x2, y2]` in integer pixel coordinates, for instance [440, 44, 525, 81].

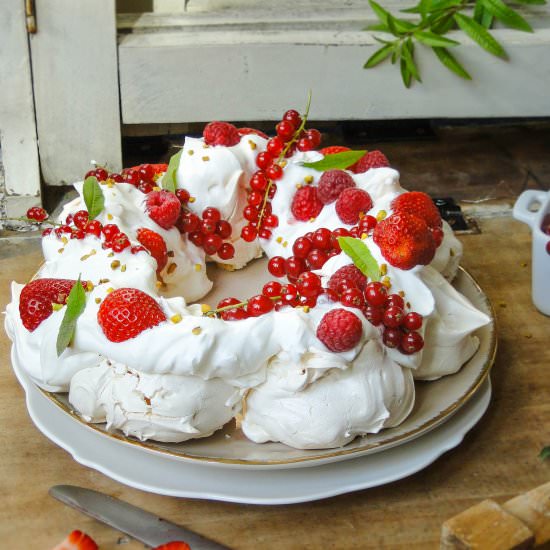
[373, 213, 436, 270]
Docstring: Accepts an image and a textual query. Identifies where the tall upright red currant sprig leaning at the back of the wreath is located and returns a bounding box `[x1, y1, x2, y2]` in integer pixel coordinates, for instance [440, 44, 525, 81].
[241, 109, 321, 242]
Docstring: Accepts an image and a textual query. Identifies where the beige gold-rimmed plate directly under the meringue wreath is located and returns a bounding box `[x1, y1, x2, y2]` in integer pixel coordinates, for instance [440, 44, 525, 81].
[36, 262, 497, 469]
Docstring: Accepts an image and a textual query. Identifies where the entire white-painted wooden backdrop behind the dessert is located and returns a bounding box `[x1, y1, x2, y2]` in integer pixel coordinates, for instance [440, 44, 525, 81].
[0, 0, 550, 200]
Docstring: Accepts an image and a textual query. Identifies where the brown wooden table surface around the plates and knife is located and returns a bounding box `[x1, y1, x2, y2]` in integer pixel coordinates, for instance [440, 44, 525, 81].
[0, 217, 550, 550]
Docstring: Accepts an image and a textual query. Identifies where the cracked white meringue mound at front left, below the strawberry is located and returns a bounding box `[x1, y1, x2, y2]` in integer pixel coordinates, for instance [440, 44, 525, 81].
[69, 360, 240, 442]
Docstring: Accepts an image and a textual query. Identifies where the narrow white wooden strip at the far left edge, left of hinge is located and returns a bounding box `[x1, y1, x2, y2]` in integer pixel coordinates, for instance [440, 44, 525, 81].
[0, 0, 40, 213]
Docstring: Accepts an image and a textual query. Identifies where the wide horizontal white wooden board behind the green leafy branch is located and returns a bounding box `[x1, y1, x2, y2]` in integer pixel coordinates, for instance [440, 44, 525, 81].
[119, 28, 550, 124]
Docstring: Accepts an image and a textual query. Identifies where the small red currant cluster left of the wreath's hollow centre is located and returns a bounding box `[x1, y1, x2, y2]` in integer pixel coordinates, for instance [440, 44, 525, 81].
[176, 206, 235, 260]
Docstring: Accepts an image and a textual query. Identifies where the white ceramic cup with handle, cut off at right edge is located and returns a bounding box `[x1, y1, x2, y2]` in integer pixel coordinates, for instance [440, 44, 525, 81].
[513, 190, 550, 315]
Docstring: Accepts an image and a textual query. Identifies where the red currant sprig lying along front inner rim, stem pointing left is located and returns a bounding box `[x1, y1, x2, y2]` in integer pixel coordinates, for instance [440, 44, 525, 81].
[212, 271, 324, 321]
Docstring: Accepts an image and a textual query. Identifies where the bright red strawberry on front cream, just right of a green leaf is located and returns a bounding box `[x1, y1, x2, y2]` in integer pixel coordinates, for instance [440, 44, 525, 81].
[97, 288, 166, 342]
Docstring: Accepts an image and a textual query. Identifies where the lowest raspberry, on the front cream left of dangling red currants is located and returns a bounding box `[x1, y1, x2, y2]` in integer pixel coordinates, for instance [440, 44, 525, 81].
[317, 308, 363, 352]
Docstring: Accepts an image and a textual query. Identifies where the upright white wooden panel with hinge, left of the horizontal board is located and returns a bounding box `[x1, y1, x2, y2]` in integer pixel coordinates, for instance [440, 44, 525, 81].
[31, 0, 122, 185]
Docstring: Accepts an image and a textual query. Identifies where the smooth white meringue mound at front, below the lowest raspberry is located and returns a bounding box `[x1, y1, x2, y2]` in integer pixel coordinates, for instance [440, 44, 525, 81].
[242, 340, 414, 449]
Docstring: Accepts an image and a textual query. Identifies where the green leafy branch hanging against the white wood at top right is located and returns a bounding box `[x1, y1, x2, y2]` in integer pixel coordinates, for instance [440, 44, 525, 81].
[364, 0, 546, 88]
